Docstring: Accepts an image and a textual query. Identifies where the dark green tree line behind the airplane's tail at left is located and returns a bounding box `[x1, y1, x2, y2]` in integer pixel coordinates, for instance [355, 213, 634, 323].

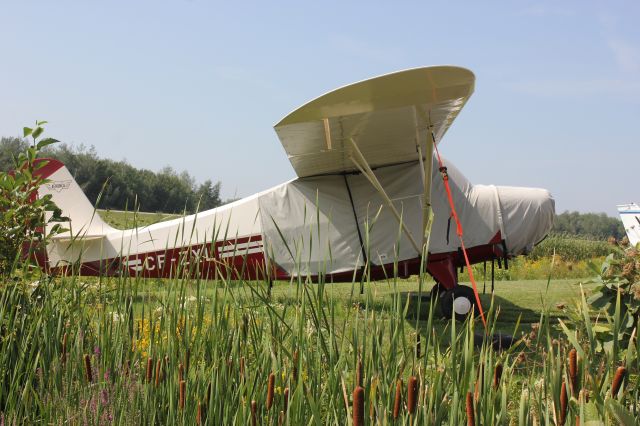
[0, 137, 222, 213]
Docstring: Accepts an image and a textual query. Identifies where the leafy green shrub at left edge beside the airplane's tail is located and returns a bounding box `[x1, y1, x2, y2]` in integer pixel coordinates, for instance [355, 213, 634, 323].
[0, 121, 65, 276]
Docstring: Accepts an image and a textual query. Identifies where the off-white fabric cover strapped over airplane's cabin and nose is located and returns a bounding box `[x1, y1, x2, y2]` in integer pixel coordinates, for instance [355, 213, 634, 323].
[259, 159, 554, 276]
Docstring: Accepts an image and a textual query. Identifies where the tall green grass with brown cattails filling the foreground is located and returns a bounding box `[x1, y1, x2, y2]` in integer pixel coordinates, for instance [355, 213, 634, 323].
[0, 256, 640, 425]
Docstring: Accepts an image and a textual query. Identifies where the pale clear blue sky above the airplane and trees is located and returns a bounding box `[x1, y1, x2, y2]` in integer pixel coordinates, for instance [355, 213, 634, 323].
[0, 0, 640, 215]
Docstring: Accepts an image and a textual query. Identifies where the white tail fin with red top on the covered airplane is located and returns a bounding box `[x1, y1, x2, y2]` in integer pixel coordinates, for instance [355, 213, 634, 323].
[37, 158, 114, 239]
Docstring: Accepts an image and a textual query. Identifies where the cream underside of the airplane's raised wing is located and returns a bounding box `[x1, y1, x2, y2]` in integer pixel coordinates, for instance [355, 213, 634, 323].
[275, 66, 475, 177]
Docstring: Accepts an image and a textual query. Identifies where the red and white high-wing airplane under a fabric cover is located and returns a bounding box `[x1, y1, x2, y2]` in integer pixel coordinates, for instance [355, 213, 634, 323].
[39, 66, 554, 316]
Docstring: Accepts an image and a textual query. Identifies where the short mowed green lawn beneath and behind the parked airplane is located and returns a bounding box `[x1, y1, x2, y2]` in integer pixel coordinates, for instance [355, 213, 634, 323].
[126, 279, 595, 336]
